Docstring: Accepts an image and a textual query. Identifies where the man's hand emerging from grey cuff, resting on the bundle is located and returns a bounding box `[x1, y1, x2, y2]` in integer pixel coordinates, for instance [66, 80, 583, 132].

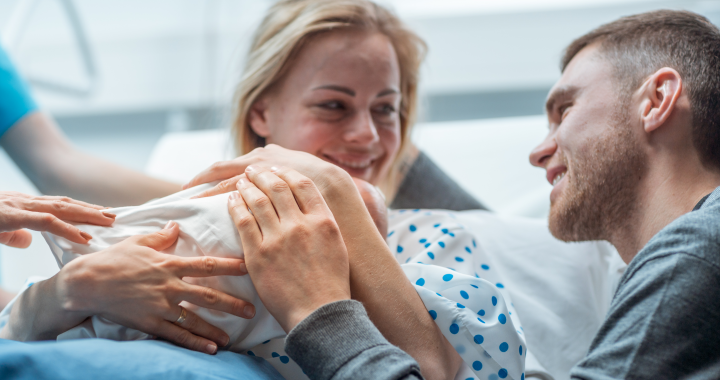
[228, 165, 350, 332]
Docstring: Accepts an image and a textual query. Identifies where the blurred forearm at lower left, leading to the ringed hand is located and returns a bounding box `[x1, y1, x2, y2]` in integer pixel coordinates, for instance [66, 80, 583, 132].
[0, 275, 86, 341]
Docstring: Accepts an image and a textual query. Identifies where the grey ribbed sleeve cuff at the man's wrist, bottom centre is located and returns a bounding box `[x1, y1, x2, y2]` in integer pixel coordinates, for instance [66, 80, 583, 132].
[285, 300, 423, 380]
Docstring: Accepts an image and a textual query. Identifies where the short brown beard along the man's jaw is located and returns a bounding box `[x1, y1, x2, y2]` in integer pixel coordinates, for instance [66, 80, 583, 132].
[549, 115, 647, 241]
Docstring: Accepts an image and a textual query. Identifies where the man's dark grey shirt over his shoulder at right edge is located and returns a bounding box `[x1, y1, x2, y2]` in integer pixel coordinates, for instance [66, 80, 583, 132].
[571, 187, 720, 379]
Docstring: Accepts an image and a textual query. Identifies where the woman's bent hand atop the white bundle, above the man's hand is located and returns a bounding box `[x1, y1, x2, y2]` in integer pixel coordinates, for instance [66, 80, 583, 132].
[183, 144, 349, 198]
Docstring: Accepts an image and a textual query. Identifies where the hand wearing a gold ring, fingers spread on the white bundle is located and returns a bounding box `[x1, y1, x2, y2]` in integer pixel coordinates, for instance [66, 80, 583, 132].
[58, 222, 255, 354]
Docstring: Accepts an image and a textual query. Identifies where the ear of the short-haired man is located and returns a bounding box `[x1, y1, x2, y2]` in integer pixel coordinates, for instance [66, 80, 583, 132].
[641, 67, 683, 133]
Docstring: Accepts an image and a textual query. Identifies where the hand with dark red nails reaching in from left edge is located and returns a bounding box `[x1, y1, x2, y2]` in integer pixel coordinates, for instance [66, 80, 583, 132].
[0, 191, 115, 248]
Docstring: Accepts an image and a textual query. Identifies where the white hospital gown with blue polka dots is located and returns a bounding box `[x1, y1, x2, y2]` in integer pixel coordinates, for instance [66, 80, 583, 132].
[247, 210, 527, 380]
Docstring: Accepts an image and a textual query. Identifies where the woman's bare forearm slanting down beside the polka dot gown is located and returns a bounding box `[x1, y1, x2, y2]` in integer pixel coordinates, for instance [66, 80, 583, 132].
[319, 172, 461, 379]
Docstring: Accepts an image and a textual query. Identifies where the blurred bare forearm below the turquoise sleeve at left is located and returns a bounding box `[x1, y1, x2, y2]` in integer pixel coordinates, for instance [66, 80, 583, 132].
[0, 112, 180, 206]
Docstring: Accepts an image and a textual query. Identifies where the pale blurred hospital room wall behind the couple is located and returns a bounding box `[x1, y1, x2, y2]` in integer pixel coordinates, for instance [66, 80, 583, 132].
[0, 0, 720, 287]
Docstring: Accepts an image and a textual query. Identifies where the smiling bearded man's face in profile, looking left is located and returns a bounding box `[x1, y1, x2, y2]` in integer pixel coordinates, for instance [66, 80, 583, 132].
[530, 45, 646, 241]
